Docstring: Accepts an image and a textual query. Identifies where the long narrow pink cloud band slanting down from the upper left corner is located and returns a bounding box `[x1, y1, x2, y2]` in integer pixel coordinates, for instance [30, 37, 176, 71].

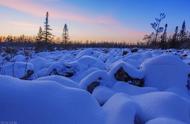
[0, 0, 119, 25]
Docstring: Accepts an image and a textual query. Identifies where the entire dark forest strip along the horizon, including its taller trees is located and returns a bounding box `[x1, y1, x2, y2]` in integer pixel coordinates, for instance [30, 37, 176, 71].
[0, 12, 190, 51]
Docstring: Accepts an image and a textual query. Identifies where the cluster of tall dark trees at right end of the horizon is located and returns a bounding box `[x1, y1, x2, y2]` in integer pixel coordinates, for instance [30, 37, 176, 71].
[144, 13, 190, 49]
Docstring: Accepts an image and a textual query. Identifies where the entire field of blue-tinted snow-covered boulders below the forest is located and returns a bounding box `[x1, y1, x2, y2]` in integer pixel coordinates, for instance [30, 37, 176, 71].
[0, 48, 190, 124]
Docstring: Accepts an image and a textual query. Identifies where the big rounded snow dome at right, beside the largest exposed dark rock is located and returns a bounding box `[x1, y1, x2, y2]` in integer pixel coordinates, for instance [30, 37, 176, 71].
[142, 55, 189, 90]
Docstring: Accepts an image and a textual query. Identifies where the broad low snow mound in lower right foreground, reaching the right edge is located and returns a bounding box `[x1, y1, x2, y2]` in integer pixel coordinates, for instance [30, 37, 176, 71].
[133, 92, 190, 123]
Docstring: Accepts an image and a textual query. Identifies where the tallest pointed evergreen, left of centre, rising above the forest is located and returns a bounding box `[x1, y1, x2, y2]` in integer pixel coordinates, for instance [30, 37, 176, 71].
[43, 12, 53, 42]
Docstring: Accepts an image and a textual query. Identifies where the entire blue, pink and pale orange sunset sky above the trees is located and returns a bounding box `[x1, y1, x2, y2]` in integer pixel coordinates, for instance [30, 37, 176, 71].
[0, 0, 190, 43]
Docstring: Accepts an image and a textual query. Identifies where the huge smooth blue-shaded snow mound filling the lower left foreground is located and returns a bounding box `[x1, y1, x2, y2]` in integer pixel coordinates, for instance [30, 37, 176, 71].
[0, 76, 105, 124]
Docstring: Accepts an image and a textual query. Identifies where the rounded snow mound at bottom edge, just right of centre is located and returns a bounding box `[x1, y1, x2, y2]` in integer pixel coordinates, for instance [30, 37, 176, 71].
[103, 93, 136, 124]
